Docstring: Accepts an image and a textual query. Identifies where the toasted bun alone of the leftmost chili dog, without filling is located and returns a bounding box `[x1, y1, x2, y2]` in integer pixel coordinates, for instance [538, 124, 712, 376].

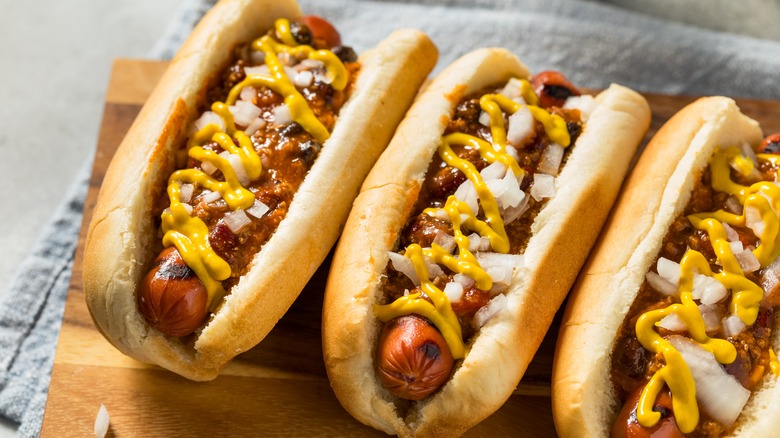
[84, 0, 437, 380]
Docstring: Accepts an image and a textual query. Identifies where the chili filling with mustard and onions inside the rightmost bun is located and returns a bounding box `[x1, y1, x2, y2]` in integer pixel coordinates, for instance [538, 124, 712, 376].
[610, 135, 780, 437]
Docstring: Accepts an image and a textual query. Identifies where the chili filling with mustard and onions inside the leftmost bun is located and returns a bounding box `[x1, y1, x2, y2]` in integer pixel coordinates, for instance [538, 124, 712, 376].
[139, 19, 359, 336]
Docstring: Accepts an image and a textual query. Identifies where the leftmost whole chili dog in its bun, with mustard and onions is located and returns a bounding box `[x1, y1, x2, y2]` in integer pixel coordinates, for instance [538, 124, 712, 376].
[84, 0, 437, 380]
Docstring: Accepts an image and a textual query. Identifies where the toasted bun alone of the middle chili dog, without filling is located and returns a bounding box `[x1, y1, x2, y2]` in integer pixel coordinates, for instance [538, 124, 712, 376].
[323, 49, 650, 436]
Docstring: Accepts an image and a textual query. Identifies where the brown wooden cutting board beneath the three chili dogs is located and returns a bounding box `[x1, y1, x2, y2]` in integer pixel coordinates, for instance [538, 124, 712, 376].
[42, 60, 780, 437]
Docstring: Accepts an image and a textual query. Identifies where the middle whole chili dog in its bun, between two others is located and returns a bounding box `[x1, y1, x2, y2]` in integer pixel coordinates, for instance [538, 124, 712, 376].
[323, 49, 650, 436]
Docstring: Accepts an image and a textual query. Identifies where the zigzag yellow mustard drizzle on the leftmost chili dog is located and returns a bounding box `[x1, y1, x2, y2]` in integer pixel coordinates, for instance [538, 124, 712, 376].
[162, 18, 348, 312]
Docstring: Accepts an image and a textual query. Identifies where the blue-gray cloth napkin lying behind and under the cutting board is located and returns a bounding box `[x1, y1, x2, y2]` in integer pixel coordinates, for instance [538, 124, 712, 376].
[0, 0, 780, 436]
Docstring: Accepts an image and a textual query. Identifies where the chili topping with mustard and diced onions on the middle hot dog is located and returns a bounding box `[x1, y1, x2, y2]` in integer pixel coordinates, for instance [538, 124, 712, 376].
[374, 72, 593, 400]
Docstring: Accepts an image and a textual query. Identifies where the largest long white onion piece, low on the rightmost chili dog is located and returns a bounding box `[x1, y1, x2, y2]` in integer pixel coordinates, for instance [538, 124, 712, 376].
[669, 336, 750, 428]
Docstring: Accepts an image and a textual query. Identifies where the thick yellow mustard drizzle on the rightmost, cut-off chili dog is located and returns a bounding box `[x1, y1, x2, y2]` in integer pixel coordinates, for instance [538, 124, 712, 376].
[636, 147, 780, 433]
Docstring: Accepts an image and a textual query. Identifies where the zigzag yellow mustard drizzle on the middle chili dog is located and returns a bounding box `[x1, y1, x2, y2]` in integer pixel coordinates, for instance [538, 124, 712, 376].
[374, 79, 571, 359]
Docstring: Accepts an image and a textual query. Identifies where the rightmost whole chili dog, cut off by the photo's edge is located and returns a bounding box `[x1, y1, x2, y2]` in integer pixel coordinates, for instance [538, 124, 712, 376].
[553, 97, 780, 437]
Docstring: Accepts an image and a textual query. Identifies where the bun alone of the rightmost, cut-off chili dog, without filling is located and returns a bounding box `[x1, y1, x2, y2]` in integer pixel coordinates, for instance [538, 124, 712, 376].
[552, 97, 780, 437]
